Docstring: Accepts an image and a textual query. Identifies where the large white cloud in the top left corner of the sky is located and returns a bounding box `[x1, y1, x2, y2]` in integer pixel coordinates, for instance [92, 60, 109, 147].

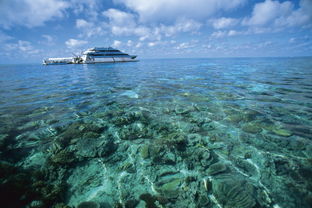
[0, 0, 69, 28]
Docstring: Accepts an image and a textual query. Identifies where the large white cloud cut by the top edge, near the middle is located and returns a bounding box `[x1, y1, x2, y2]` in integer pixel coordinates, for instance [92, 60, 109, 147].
[114, 0, 246, 23]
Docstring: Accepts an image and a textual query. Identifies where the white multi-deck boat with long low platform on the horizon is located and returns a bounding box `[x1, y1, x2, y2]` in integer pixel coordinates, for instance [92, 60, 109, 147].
[43, 47, 138, 65]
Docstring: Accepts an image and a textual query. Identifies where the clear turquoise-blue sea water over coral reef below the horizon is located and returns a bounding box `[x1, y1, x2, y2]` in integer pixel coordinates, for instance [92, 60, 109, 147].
[0, 58, 312, 208]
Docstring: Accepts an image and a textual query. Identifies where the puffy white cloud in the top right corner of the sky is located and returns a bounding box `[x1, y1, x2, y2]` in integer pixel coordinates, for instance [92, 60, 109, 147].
[243, 0, 312, 27]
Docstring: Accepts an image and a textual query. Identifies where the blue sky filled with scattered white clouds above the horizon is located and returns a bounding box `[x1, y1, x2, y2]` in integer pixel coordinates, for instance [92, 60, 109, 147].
[0, 0, 312, 64]
